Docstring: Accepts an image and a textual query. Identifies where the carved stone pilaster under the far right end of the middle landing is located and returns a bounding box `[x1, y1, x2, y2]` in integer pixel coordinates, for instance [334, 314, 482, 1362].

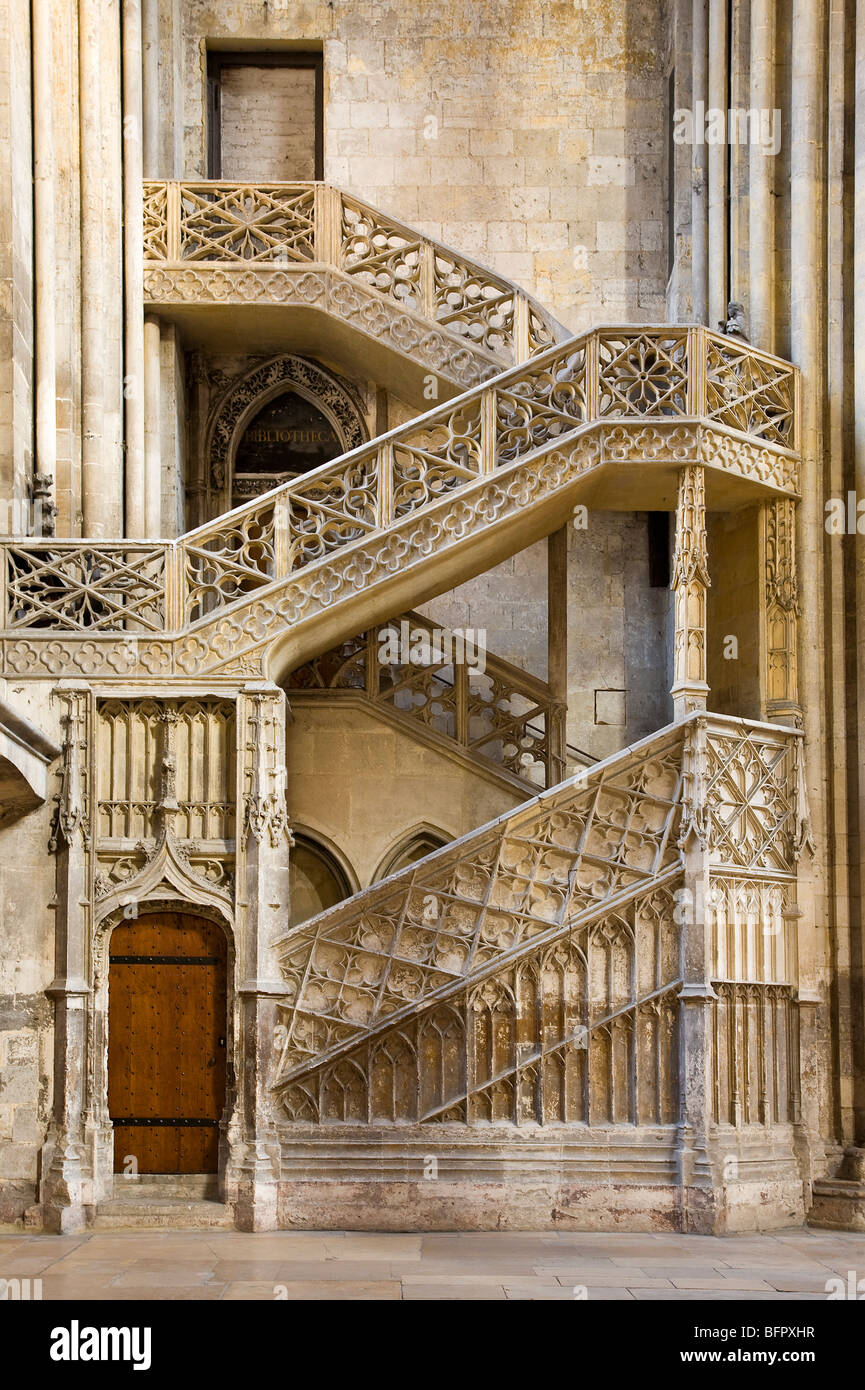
[761, 498, 802, 727]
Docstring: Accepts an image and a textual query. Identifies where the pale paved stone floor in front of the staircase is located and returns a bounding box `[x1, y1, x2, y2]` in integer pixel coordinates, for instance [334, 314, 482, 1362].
[0, 1230, 865, 1301]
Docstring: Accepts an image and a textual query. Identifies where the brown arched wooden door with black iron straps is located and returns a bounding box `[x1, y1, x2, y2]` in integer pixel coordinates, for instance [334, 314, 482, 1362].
[108, 912, 227, 1173]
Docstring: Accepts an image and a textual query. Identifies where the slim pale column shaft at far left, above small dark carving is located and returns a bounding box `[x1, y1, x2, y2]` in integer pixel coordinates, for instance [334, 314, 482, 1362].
[31, 0, 57, 531]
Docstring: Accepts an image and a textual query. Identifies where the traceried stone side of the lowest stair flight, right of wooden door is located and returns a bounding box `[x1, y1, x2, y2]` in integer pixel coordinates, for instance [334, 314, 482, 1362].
[275, 716, 807, 1125]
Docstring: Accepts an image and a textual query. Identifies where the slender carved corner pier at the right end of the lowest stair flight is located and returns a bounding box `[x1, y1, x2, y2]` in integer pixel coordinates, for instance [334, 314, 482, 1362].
[677, 717, 722, 1234]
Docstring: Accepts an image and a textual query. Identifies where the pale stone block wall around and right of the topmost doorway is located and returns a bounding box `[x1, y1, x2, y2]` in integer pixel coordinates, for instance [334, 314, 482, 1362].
[178, 0, 666, 331]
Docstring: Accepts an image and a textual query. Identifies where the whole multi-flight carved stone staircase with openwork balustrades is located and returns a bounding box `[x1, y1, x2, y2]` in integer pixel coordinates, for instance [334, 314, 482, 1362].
[0, 185, 809, 1230]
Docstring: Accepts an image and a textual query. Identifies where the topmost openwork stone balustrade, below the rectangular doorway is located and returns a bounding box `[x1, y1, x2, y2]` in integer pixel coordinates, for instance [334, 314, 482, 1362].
[143, 182, 565, 386]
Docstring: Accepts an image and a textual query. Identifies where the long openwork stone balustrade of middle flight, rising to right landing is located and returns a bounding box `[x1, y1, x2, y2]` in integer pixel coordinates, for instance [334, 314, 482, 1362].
[0, 325, 798, 681]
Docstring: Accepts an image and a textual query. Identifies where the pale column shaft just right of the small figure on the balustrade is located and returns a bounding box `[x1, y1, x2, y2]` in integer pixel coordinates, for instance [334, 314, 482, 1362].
[748, 0, 780, 352]
